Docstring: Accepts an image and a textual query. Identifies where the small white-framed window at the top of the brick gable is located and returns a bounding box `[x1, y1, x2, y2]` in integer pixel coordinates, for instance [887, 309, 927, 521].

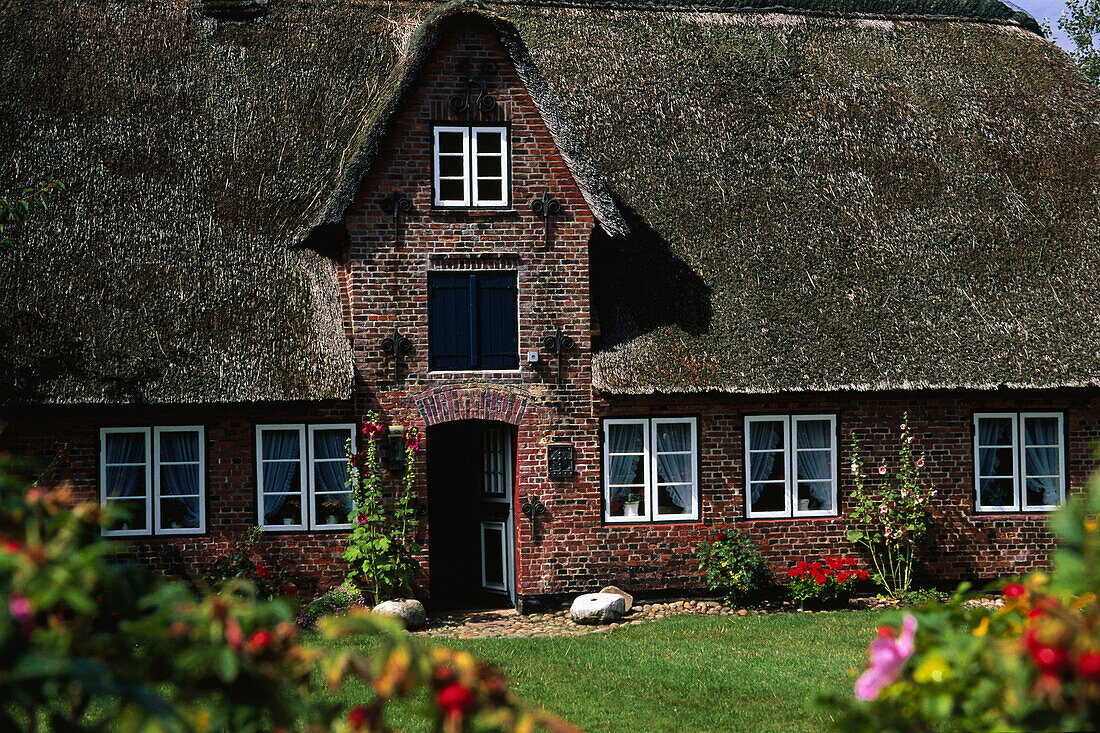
[432, 125, 509, 207]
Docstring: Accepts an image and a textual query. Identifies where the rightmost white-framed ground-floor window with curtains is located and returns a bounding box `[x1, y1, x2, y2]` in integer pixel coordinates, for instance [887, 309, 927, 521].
[974, 413, 1066, 512]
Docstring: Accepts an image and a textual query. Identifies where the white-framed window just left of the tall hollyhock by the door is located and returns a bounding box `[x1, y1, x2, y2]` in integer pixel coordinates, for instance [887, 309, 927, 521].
[256, 423, 355, 530]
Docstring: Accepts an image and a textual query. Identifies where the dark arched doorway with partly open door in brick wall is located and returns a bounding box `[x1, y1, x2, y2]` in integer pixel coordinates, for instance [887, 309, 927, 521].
[428, 420, 515, 608]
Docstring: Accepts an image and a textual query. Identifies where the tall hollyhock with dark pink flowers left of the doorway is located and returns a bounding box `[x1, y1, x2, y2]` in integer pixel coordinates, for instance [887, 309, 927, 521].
[343, 413, 420, 604]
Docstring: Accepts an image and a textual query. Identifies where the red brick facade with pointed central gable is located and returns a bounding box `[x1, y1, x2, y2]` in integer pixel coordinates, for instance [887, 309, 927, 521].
[0, 19, 1100, 597]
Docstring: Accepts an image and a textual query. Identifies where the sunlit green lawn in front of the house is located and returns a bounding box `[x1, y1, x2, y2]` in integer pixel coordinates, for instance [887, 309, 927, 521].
[314, 612, 879, 733]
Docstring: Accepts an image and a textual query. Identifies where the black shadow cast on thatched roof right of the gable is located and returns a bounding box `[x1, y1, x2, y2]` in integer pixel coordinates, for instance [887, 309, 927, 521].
[589, 200, 712, 348]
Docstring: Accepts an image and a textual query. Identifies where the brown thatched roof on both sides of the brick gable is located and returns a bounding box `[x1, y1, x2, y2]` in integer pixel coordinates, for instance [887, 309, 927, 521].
[0, 0, 1100, 402]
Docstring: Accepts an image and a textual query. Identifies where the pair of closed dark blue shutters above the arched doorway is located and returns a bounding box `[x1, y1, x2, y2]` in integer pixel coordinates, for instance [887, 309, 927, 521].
[428, 271, 519, 371]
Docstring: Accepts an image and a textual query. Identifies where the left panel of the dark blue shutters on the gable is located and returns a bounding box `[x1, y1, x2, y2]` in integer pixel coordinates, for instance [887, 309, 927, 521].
[428, 272, 474, 371]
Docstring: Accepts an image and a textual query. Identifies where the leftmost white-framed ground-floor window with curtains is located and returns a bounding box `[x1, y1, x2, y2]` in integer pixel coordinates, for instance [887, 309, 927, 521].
[99, 425, 206, 537]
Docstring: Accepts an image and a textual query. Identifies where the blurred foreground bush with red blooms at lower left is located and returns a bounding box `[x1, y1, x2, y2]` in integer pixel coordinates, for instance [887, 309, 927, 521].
[0, 458, 574, 733]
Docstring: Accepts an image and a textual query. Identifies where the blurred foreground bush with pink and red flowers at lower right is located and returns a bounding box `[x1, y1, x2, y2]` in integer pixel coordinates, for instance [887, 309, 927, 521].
[827, 464, 1100, 731]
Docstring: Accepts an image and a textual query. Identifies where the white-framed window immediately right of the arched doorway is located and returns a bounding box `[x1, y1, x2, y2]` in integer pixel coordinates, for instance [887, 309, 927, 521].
[604, 417, 699, 523]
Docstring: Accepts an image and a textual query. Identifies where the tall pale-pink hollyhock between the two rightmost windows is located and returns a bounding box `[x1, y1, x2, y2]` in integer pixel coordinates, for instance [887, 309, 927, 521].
[847, 413, 936, 597]
